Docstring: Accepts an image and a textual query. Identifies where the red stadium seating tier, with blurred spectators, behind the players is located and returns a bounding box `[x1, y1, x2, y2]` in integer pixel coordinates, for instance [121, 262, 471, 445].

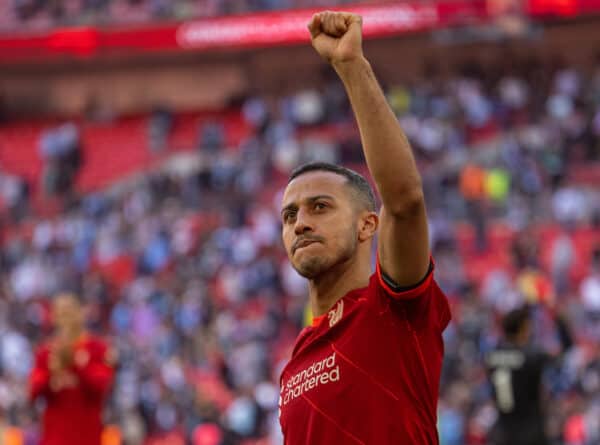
[0, 57, 600, 445]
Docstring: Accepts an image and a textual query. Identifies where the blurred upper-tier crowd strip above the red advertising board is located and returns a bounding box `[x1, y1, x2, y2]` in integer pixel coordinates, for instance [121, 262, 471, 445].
[0, 0, 364, 31]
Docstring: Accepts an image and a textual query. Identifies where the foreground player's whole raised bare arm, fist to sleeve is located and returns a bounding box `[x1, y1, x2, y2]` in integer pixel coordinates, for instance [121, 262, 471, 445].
[308, 11, 429, 287]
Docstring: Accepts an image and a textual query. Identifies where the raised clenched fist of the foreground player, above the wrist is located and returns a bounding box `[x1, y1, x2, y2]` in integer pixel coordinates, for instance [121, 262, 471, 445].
[308, 11, 363, 65]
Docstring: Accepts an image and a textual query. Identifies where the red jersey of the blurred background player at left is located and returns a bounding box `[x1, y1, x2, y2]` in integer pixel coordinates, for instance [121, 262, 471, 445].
[29, 335, 114, 445]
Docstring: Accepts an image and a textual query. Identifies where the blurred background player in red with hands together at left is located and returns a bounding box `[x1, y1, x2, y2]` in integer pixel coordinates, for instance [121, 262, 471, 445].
[29, 294, 116, 445]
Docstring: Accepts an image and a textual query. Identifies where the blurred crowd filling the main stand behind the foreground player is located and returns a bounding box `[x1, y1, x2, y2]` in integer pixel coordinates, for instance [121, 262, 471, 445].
[0, 53, 600, 445]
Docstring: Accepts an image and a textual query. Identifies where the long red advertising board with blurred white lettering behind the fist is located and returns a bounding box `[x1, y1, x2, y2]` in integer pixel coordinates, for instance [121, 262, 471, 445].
[0, 0, 487, 63]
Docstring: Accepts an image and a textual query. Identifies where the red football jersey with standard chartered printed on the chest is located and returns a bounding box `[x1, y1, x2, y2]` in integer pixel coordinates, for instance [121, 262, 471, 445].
[279, 264, 450, 445]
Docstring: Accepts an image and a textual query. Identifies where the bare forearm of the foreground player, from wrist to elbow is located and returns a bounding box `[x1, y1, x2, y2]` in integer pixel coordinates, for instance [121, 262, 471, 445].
[333, 57, 423, 215]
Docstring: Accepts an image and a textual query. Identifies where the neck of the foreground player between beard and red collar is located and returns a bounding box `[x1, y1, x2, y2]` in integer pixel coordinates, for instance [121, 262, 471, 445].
[308, 255, 371, 317]
